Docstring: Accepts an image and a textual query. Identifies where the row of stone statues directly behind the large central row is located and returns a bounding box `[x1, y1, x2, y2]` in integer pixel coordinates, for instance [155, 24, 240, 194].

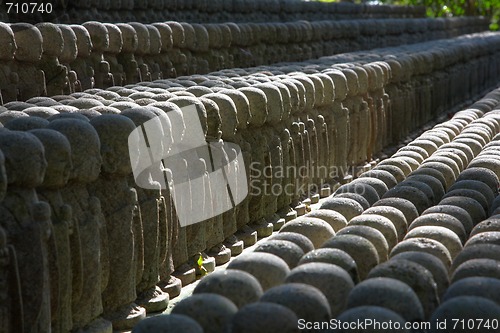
[0, 18, 485, 103]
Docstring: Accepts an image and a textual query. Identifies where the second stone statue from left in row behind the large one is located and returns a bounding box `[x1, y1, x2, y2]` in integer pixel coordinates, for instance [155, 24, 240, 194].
[11, 23, 47, 101]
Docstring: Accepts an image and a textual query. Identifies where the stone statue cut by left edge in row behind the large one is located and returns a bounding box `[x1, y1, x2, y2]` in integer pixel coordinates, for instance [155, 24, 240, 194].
[0, 22, 19, 104]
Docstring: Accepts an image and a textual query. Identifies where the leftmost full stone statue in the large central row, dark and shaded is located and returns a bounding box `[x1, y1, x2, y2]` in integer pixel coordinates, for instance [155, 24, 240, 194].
[0, 130, 51, 332]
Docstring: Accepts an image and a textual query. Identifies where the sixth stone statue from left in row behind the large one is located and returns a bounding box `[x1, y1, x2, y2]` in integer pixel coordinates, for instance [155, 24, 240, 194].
[83, 21, 115, 89]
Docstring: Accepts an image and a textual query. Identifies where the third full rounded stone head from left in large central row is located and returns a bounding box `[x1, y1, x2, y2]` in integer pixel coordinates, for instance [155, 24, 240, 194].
[48, 118, 102, 183]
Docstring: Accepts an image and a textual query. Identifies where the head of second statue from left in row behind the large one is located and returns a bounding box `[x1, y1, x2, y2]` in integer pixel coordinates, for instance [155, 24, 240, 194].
[10, 23, 43, 62]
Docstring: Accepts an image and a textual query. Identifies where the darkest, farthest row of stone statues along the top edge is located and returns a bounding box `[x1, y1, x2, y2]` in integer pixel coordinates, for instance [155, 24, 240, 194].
[2, 0, 425, 24]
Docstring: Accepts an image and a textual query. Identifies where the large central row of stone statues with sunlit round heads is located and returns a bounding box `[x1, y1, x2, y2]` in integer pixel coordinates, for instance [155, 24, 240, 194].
[0, 29, 500, 332]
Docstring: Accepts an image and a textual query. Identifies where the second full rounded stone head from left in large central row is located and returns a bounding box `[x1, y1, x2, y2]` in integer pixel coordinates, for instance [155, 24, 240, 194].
[29, 129, 73, 189]
